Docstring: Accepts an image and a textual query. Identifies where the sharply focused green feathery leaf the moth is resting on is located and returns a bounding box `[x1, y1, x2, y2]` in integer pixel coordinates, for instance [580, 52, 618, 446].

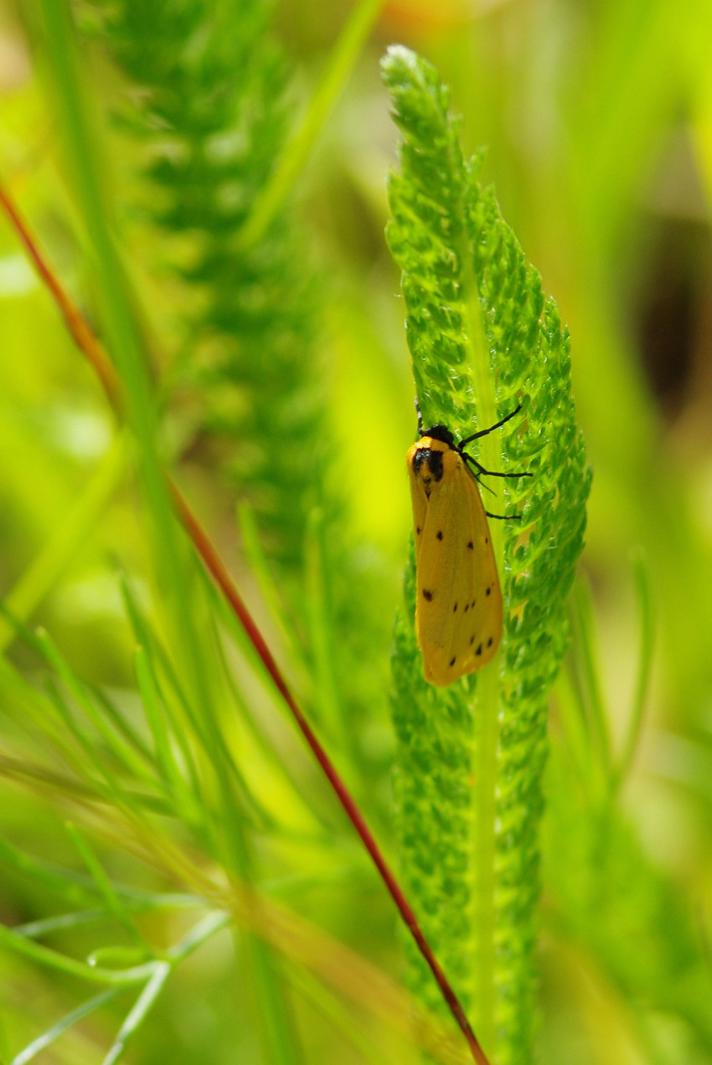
[383, 47, 590, 1065]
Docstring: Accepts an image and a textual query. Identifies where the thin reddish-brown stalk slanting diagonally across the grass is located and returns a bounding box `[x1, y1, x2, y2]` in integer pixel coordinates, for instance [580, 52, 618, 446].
[0, 186, 490, 1065]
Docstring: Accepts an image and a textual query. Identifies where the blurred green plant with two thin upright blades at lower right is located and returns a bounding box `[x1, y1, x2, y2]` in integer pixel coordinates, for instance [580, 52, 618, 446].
[545, 555, 712, 1065]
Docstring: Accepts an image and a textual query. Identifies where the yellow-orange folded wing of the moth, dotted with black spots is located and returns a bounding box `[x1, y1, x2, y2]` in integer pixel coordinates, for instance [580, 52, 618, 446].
[414, 450, 502, 685]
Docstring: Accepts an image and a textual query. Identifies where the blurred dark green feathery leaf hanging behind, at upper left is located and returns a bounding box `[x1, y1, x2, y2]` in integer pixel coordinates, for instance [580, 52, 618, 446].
[90, 0, 332, 576]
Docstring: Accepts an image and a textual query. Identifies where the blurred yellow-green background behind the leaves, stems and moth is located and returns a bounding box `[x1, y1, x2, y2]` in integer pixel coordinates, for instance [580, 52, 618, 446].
[0, 0, 712, 1065]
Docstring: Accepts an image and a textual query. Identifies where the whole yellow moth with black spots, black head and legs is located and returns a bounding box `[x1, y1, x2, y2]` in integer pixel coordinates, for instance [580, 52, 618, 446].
[407, 407, 531, 685]
